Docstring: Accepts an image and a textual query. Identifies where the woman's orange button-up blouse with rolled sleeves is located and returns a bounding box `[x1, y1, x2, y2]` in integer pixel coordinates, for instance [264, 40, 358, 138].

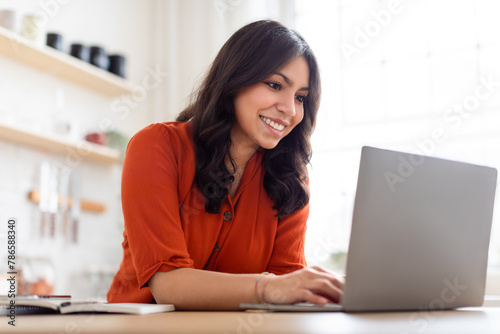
[108, 122, 309, 303]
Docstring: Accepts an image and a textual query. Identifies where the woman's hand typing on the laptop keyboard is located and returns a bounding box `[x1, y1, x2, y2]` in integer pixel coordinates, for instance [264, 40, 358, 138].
[257, 266, 344, 305]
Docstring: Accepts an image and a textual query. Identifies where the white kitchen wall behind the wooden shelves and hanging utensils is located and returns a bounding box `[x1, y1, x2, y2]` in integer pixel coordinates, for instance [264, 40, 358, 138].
[0, 0, 158, 298]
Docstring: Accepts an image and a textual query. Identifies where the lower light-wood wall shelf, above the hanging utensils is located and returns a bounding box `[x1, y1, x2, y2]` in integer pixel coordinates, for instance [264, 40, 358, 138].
[0, 123, 120, 164]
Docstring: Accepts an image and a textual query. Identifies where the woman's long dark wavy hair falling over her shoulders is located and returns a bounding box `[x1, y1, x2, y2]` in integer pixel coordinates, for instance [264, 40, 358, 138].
[177, 20, 321, 216]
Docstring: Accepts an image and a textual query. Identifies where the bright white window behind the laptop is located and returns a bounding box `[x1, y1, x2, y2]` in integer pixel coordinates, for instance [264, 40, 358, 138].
[296, 0, 500, 294]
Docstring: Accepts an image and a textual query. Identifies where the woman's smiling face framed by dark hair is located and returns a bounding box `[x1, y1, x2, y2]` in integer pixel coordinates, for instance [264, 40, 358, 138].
[231, 56, 309, 149]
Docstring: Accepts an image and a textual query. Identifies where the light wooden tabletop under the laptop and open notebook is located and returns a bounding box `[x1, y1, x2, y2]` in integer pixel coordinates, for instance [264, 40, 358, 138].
[0, 307, 500, 334]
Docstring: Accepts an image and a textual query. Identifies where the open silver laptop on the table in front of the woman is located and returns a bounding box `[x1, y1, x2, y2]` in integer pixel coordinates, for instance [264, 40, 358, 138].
[240, 147, 497, 312]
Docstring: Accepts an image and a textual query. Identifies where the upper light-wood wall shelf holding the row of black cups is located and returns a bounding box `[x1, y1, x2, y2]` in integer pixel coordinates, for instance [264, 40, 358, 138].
[0, 27, 133, 96]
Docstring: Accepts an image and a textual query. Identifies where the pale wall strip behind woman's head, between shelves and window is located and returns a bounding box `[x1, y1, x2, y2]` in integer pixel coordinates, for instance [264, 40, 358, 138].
[152, 0, 294, 121]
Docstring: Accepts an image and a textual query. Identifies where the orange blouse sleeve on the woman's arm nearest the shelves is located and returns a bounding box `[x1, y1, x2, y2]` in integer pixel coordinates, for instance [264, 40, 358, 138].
[122, 125, 193, 287]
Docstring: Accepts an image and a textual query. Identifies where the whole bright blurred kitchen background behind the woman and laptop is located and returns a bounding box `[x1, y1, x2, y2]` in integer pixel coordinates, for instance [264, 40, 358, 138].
[0, 0, 500, 299]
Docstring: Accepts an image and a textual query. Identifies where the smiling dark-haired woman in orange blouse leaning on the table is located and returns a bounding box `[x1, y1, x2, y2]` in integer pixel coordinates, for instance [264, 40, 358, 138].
[108, 20, 343, 310]
